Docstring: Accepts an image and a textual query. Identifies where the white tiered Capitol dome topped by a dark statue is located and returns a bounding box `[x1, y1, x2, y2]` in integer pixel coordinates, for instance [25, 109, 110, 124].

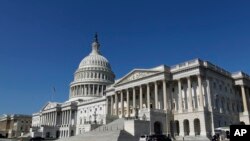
[69, 34, 115, 100]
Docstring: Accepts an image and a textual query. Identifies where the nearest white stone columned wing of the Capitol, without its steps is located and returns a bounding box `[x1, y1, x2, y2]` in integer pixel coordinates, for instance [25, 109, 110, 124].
[106, 59, 250, 138]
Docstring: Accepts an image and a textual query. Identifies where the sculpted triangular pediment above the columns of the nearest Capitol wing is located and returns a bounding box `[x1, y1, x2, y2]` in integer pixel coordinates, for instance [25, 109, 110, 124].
[115, 69, 160, 85]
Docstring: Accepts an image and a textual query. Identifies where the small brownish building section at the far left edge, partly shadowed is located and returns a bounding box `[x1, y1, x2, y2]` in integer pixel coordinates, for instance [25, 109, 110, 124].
[0, 114, 32, 138]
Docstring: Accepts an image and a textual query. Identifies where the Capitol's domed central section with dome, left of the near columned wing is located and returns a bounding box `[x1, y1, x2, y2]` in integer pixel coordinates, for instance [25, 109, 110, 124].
[31, 35, 115, 138]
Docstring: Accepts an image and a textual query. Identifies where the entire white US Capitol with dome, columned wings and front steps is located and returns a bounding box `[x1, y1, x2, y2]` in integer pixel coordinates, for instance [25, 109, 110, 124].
[31, 35, 250, 140]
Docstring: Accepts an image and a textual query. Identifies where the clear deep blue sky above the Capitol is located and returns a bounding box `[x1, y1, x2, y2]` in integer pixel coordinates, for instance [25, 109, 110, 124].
[0, 0, 250, 114]
